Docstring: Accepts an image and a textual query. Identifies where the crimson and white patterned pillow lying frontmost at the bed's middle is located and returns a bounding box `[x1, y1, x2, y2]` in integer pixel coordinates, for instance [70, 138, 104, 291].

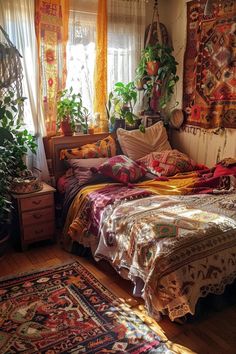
[92, 155, 146, 184]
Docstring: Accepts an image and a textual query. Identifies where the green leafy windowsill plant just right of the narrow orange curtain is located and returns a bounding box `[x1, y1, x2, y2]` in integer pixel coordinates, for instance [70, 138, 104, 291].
[106, 81, 142, 130]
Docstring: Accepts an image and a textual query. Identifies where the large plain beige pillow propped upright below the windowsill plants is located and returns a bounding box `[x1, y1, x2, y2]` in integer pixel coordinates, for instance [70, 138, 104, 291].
[116, 122, 171, 160]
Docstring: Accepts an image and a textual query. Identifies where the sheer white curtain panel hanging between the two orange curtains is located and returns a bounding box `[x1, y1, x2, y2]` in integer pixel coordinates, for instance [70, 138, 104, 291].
[66, 0, 97, 113]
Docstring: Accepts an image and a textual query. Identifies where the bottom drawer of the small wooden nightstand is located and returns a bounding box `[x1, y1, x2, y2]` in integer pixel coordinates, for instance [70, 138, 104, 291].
[23, 221, 54, 241]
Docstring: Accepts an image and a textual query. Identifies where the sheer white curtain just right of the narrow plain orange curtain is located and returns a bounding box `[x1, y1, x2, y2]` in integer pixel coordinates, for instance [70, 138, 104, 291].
[107, 0, 146, 92]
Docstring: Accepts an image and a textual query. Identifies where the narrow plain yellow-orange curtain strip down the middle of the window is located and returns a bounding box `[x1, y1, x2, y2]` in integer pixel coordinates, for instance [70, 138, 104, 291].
[93, 0, 107, 130]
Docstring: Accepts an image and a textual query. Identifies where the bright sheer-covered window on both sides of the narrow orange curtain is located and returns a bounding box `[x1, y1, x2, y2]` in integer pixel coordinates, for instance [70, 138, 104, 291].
[66, 0, 145, 113]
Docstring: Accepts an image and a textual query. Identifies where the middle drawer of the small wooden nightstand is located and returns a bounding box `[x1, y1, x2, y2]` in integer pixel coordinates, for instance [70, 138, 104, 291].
[22, 207, 54, 226]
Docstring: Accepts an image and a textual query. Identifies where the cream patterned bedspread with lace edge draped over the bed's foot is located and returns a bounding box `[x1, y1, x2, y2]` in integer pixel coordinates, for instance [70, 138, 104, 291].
[95, 194, 236, 320]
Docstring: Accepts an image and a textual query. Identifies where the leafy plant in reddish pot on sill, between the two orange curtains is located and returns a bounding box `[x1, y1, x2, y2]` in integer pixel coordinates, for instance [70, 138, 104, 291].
[57, 87, 88, 135]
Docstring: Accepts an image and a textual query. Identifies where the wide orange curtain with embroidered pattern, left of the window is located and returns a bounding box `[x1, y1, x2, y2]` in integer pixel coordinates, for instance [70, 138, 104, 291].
[35, 0, 69, 136]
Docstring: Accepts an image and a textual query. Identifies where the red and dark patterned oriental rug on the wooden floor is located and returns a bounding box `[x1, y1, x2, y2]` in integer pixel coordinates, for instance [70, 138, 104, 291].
[0, 262, 170, 354]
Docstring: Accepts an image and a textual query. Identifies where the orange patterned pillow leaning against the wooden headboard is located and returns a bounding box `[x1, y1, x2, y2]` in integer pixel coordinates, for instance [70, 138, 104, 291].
[60, 135, 116, 160]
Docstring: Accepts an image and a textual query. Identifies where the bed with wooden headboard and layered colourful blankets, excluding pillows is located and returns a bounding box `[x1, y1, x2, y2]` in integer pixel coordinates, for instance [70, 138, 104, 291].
[49, 126, 236, 320]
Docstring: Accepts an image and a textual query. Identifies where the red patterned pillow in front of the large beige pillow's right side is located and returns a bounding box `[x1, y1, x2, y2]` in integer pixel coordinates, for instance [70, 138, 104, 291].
[137, 150, 205, 176]
